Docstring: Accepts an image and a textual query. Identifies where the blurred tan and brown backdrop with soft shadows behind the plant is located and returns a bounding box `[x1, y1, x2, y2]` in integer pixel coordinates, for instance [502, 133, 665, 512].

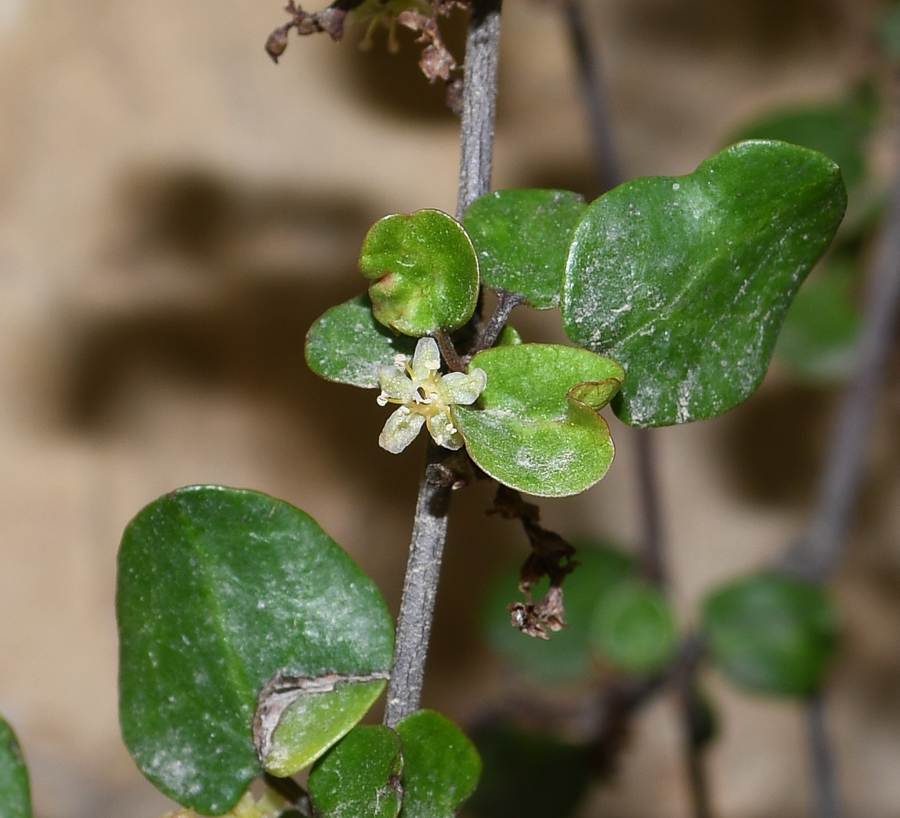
[0, 0, 900, 818]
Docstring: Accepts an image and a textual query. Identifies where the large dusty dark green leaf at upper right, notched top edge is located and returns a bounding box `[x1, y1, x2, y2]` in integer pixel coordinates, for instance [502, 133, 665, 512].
[562, 142, 846, 426]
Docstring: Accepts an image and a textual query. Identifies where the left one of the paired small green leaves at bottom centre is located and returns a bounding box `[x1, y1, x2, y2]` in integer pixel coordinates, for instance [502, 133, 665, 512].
[309, 727, 403, 818]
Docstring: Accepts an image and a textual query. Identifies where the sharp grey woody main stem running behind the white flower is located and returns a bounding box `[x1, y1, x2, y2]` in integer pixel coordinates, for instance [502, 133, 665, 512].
[384, 0, 500, 727]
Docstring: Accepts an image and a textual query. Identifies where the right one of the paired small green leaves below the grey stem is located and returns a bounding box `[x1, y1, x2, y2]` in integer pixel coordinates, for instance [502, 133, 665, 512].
[397, 710, 481, 818]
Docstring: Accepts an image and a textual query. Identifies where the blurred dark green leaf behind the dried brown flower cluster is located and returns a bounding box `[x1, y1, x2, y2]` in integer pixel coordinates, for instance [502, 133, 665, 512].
[484, 543, 635, 685]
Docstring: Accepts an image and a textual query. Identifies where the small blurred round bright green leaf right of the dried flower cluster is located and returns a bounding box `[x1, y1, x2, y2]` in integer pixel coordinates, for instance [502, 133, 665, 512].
[591, 582, 678, 674]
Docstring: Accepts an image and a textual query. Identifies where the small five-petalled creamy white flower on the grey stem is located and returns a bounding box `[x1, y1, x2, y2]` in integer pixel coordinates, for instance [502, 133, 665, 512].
[376, 337, 487, 454]
